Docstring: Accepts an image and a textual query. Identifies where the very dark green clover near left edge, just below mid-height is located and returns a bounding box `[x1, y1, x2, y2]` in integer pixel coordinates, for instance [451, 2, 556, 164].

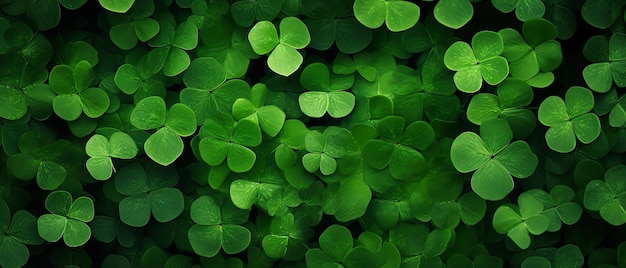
[7, 131, 68, 190]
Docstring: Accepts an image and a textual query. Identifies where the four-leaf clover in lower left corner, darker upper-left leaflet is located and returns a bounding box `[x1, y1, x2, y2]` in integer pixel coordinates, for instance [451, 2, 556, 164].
[37, 191, 94, 247]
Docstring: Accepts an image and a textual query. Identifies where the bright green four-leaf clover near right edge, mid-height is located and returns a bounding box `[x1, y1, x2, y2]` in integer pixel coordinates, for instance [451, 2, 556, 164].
[538, 86, 601, 153]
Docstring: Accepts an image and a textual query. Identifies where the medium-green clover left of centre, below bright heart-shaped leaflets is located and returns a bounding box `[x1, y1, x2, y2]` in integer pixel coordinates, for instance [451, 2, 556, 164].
[198, 114, 262, 173]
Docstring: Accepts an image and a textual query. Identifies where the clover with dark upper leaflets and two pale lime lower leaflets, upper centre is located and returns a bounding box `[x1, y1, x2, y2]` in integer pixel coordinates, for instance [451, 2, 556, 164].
[298, 62, 356, 118]
